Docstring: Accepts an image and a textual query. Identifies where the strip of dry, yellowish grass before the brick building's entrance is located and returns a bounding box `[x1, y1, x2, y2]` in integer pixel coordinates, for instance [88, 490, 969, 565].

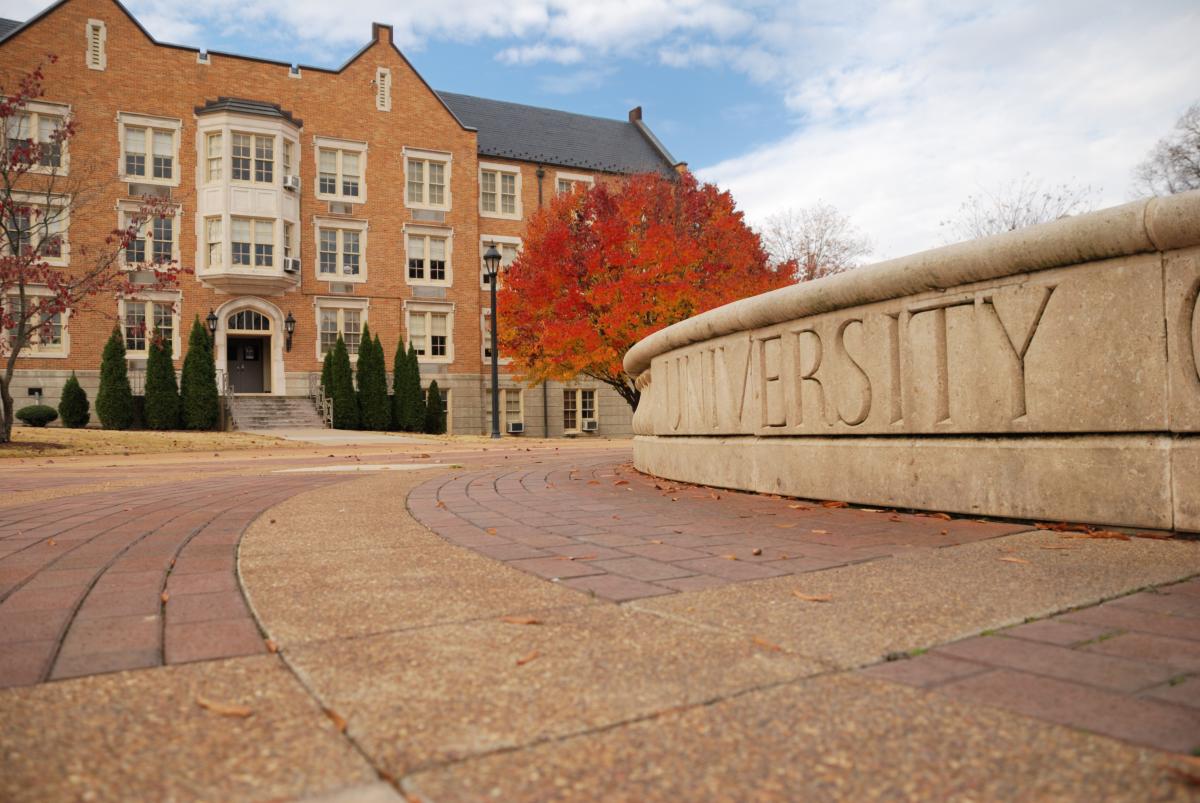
[0, 426, 297, 459]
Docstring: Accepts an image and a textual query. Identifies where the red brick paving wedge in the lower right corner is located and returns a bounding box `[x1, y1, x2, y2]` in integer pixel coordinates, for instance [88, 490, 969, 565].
[863, 577, 1200, 754]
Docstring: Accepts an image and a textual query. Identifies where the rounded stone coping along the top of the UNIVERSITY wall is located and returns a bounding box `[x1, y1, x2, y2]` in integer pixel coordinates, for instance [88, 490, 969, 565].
[624, 191, 1200, 377]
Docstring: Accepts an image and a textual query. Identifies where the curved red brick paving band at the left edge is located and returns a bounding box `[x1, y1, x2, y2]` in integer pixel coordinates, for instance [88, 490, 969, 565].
[0, 474, 338, 688]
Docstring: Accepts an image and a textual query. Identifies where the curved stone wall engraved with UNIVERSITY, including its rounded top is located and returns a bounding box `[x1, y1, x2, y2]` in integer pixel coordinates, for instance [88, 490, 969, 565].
[625, 192, 1200, 532]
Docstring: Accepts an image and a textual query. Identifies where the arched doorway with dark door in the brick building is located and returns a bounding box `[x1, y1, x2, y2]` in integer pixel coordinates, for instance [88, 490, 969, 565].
[215, 298, 284, 395]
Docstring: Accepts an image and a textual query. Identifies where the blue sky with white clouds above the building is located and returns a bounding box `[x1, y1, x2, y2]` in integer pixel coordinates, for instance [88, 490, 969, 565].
[0, 0, 1200, 259]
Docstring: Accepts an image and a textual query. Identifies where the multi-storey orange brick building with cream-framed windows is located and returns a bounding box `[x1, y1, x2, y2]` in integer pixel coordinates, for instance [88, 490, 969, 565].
[0, 0, 678, 436]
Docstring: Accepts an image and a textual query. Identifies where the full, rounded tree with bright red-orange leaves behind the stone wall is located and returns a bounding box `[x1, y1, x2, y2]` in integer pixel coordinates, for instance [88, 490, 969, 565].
[498, 173, 794, 409]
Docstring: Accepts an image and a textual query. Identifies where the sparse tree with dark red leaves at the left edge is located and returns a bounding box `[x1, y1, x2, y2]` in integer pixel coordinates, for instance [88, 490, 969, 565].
[0, 56, 179, 443]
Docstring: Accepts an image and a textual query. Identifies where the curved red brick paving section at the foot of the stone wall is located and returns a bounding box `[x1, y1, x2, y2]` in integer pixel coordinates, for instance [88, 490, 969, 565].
[409, 455, 1030, 601]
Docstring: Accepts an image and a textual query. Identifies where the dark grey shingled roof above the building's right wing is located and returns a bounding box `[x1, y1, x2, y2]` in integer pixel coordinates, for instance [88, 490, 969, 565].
[438, 92, 676, 173]
